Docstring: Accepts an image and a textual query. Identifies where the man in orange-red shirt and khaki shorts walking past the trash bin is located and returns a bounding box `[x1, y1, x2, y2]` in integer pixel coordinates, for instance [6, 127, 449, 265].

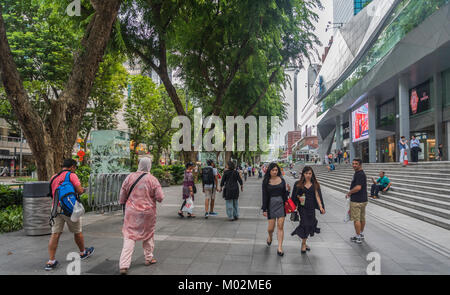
[45, 159, 94, 271]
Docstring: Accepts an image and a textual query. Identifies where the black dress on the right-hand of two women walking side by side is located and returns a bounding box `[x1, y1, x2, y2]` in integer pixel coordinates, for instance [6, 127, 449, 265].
[291, 185, 323, 239]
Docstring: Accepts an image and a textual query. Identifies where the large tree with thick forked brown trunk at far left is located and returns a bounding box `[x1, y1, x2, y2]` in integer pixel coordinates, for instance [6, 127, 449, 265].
[0, 0, 121, 180]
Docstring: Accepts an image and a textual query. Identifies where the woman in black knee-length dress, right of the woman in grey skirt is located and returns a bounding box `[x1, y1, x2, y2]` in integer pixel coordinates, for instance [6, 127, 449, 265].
[291, 166, 325, 253]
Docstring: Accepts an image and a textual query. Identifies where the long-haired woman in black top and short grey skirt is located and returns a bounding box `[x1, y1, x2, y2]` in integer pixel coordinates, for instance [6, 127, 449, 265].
[261, 163, 291, 256]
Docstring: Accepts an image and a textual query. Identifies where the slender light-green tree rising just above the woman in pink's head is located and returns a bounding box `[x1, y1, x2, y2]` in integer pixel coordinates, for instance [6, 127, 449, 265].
[124, 75, 160, 163]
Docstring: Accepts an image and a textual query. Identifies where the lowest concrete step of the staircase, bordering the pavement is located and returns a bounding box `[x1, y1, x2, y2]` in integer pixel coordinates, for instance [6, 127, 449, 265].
[321, 181, 450, 230]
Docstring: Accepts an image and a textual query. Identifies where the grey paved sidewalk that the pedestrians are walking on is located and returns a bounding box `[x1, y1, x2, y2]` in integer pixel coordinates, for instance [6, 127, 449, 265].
[0, 177, 450, 275]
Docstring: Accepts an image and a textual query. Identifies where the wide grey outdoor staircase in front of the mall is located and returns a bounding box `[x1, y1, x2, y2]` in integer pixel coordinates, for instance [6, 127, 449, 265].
[295, 162, 450, 230]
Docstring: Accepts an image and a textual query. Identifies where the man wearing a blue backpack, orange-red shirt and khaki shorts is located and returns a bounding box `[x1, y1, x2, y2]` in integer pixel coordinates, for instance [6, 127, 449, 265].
[45, 159, 94, 270]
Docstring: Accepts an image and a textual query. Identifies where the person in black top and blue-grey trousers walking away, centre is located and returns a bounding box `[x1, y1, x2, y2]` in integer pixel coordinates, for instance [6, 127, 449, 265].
[219, 161, 244, 221]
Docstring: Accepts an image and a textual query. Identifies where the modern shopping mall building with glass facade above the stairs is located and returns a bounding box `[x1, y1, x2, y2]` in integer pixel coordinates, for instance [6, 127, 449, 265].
[313, 0, 450, 163]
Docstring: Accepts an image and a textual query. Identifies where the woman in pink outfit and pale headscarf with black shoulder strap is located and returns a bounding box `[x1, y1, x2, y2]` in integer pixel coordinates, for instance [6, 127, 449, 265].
[119, 158, 164, 274]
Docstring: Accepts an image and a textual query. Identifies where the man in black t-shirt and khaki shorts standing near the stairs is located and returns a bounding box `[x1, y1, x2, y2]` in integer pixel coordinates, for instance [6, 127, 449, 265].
[345, 159, 368, 244]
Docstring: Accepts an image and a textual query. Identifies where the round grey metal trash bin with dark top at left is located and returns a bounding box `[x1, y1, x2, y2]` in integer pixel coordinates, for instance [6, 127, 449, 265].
[23, 181, 52, 236]
